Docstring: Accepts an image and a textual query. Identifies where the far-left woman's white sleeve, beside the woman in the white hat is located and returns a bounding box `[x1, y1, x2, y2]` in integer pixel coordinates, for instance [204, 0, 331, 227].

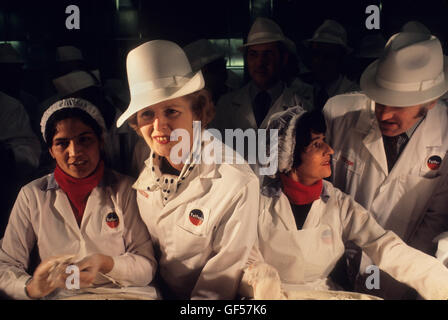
[107, 185, 157, 286]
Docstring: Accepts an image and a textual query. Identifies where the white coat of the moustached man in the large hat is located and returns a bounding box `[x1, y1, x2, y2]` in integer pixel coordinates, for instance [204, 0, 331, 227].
[324, 93, 448, 254]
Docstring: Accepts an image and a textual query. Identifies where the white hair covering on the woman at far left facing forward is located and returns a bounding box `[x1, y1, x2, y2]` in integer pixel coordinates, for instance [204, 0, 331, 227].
[40, 98, 106, 142]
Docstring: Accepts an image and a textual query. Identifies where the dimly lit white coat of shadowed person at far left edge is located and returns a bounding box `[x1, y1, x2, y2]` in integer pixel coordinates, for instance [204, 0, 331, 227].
[0, 91, 41, 174]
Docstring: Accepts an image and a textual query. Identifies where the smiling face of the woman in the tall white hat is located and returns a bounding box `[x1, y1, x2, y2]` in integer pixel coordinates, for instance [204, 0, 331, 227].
[137, 96, 199, 169]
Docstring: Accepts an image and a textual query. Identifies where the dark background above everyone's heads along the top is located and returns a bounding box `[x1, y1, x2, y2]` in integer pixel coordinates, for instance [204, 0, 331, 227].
[0, 0, 448, 99]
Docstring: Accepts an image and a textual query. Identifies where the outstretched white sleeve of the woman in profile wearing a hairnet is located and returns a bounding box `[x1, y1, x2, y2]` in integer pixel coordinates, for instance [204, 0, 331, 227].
[338, 191, 448, 299]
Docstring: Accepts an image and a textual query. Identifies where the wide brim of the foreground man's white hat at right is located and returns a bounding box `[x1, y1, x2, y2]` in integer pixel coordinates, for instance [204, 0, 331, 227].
[360, 57, 448, 107]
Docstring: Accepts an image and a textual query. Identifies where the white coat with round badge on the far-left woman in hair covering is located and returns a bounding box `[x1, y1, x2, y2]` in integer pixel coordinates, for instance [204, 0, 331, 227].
[0, 169, 157, 299]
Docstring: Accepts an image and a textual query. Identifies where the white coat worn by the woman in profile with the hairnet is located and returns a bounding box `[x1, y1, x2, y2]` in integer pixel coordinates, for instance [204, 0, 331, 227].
[252, 181, 448, 299]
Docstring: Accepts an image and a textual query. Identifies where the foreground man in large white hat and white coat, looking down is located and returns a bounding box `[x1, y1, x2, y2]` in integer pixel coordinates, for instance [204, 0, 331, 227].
[324, 33, 448, 298]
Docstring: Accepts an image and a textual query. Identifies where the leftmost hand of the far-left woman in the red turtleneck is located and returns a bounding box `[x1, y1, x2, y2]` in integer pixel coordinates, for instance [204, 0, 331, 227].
[25, 257, 68, 299]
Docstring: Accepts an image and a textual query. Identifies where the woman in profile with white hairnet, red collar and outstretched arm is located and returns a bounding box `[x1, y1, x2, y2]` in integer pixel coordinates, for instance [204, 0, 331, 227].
[243, 107, 448, 299]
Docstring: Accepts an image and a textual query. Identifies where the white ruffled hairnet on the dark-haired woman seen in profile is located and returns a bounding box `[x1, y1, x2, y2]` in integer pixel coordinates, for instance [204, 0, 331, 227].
[267, 106, 306, 173]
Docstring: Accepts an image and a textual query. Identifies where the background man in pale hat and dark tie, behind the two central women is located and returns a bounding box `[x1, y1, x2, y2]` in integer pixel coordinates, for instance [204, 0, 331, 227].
[211, 18, 312, 135]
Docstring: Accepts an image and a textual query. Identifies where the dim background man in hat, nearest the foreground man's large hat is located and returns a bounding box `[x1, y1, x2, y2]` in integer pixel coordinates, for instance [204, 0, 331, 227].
[303, 20, 359, 109]
